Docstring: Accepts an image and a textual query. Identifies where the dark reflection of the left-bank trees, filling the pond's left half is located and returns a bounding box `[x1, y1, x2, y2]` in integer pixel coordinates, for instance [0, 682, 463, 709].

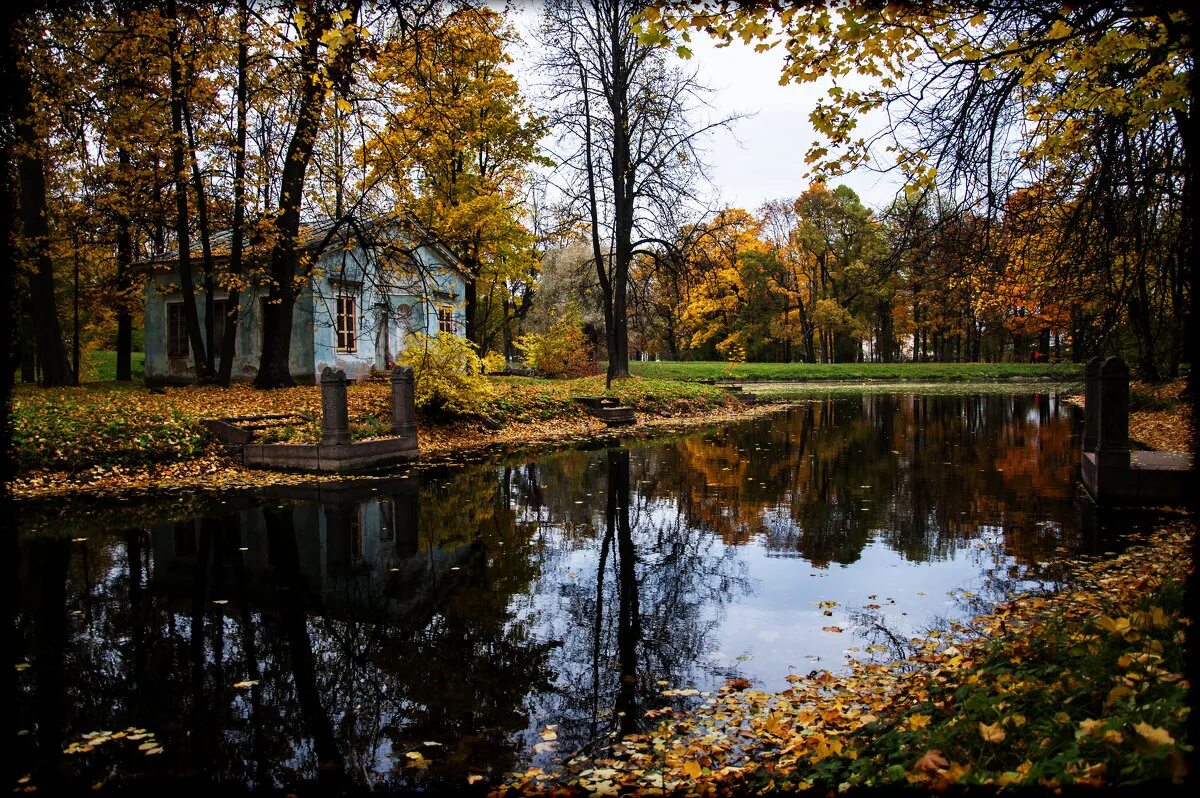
[18, 470, 550, 790]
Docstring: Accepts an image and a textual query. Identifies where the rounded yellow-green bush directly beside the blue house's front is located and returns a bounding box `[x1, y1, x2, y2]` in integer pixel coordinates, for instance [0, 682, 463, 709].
[400, 332, 492, 418]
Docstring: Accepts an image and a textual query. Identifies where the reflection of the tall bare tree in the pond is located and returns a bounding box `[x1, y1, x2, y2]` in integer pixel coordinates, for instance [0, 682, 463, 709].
[527, 449, 749, 754]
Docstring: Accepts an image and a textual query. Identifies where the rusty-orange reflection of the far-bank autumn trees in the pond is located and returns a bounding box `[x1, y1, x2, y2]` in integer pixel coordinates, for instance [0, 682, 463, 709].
[664, 395, 1076, 566]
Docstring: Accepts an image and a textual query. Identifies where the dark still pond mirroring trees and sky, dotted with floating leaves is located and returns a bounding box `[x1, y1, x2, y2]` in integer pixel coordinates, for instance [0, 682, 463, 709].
[9, 394, 1146, 790]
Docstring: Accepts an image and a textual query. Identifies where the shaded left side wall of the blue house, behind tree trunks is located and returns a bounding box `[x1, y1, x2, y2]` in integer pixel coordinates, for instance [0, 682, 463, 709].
[144, 272, 314, 385]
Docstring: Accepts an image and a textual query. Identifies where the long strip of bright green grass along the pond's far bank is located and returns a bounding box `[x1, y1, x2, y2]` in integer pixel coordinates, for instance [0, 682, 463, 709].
[629, 361, 1084, 383]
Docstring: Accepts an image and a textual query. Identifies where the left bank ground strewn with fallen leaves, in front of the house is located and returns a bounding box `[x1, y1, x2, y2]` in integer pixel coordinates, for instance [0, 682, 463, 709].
[12, 377, 763, 498]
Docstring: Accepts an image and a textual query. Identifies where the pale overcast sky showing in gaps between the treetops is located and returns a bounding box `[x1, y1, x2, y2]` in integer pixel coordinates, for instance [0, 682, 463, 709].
[501, 2, 899, 211]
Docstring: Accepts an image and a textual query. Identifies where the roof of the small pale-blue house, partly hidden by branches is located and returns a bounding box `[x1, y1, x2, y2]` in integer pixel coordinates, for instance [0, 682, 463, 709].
[132, 214, 467, 276]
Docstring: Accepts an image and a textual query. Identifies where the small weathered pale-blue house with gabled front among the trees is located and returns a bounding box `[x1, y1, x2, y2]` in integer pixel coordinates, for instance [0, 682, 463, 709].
[142, 214, 466, 384]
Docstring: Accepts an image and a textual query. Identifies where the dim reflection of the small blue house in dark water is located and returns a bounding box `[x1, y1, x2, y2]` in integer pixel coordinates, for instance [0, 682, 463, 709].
[151, 480, 482, 625]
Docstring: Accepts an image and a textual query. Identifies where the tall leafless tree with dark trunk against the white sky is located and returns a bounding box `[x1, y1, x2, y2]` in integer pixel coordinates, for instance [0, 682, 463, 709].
[541, 0, 731, 385]
